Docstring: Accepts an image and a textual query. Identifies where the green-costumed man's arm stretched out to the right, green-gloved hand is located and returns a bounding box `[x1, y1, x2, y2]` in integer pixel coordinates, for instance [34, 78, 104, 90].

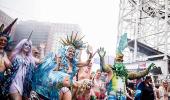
[128, 63, 156, 80]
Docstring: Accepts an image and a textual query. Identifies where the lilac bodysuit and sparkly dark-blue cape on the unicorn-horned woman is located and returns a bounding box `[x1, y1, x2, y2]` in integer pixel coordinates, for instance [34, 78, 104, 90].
[3, 55, 34, 97]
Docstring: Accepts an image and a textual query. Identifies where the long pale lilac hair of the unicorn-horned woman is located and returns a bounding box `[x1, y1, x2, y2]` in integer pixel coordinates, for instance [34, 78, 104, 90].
[11, 39, 34, 62]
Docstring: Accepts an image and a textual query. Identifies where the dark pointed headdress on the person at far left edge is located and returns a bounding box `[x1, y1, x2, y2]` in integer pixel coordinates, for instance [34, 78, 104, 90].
[0, 18, 18, 51]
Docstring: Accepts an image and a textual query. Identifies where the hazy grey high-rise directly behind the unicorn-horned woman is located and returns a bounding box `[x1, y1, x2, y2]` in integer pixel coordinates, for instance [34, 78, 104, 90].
[14, 21, 50, 46]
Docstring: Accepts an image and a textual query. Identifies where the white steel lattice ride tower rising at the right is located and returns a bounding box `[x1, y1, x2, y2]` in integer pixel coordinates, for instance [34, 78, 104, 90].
[118, 0, 170, 74]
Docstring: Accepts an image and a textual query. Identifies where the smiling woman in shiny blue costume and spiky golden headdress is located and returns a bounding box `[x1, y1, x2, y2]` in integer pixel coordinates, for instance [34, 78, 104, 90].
[33, 34, 92, 100]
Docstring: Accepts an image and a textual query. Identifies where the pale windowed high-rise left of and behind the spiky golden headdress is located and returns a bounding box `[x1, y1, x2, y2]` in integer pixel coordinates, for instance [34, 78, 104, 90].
[46, 23, 81, 51]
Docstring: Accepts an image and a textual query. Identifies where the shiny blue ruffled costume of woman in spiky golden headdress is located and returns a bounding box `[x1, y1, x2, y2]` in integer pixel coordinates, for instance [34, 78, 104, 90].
[32, 48, 76, 99]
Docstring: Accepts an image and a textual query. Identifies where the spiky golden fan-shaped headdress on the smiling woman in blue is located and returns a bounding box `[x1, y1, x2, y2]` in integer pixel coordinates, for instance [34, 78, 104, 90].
[60, 32, 86, 49]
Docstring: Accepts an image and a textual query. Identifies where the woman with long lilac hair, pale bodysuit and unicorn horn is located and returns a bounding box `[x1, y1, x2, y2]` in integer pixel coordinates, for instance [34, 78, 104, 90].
[3, 39, 35, 100]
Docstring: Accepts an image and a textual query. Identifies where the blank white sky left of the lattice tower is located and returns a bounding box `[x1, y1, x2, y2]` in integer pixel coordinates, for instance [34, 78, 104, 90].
[0, 0, 119, 56]
